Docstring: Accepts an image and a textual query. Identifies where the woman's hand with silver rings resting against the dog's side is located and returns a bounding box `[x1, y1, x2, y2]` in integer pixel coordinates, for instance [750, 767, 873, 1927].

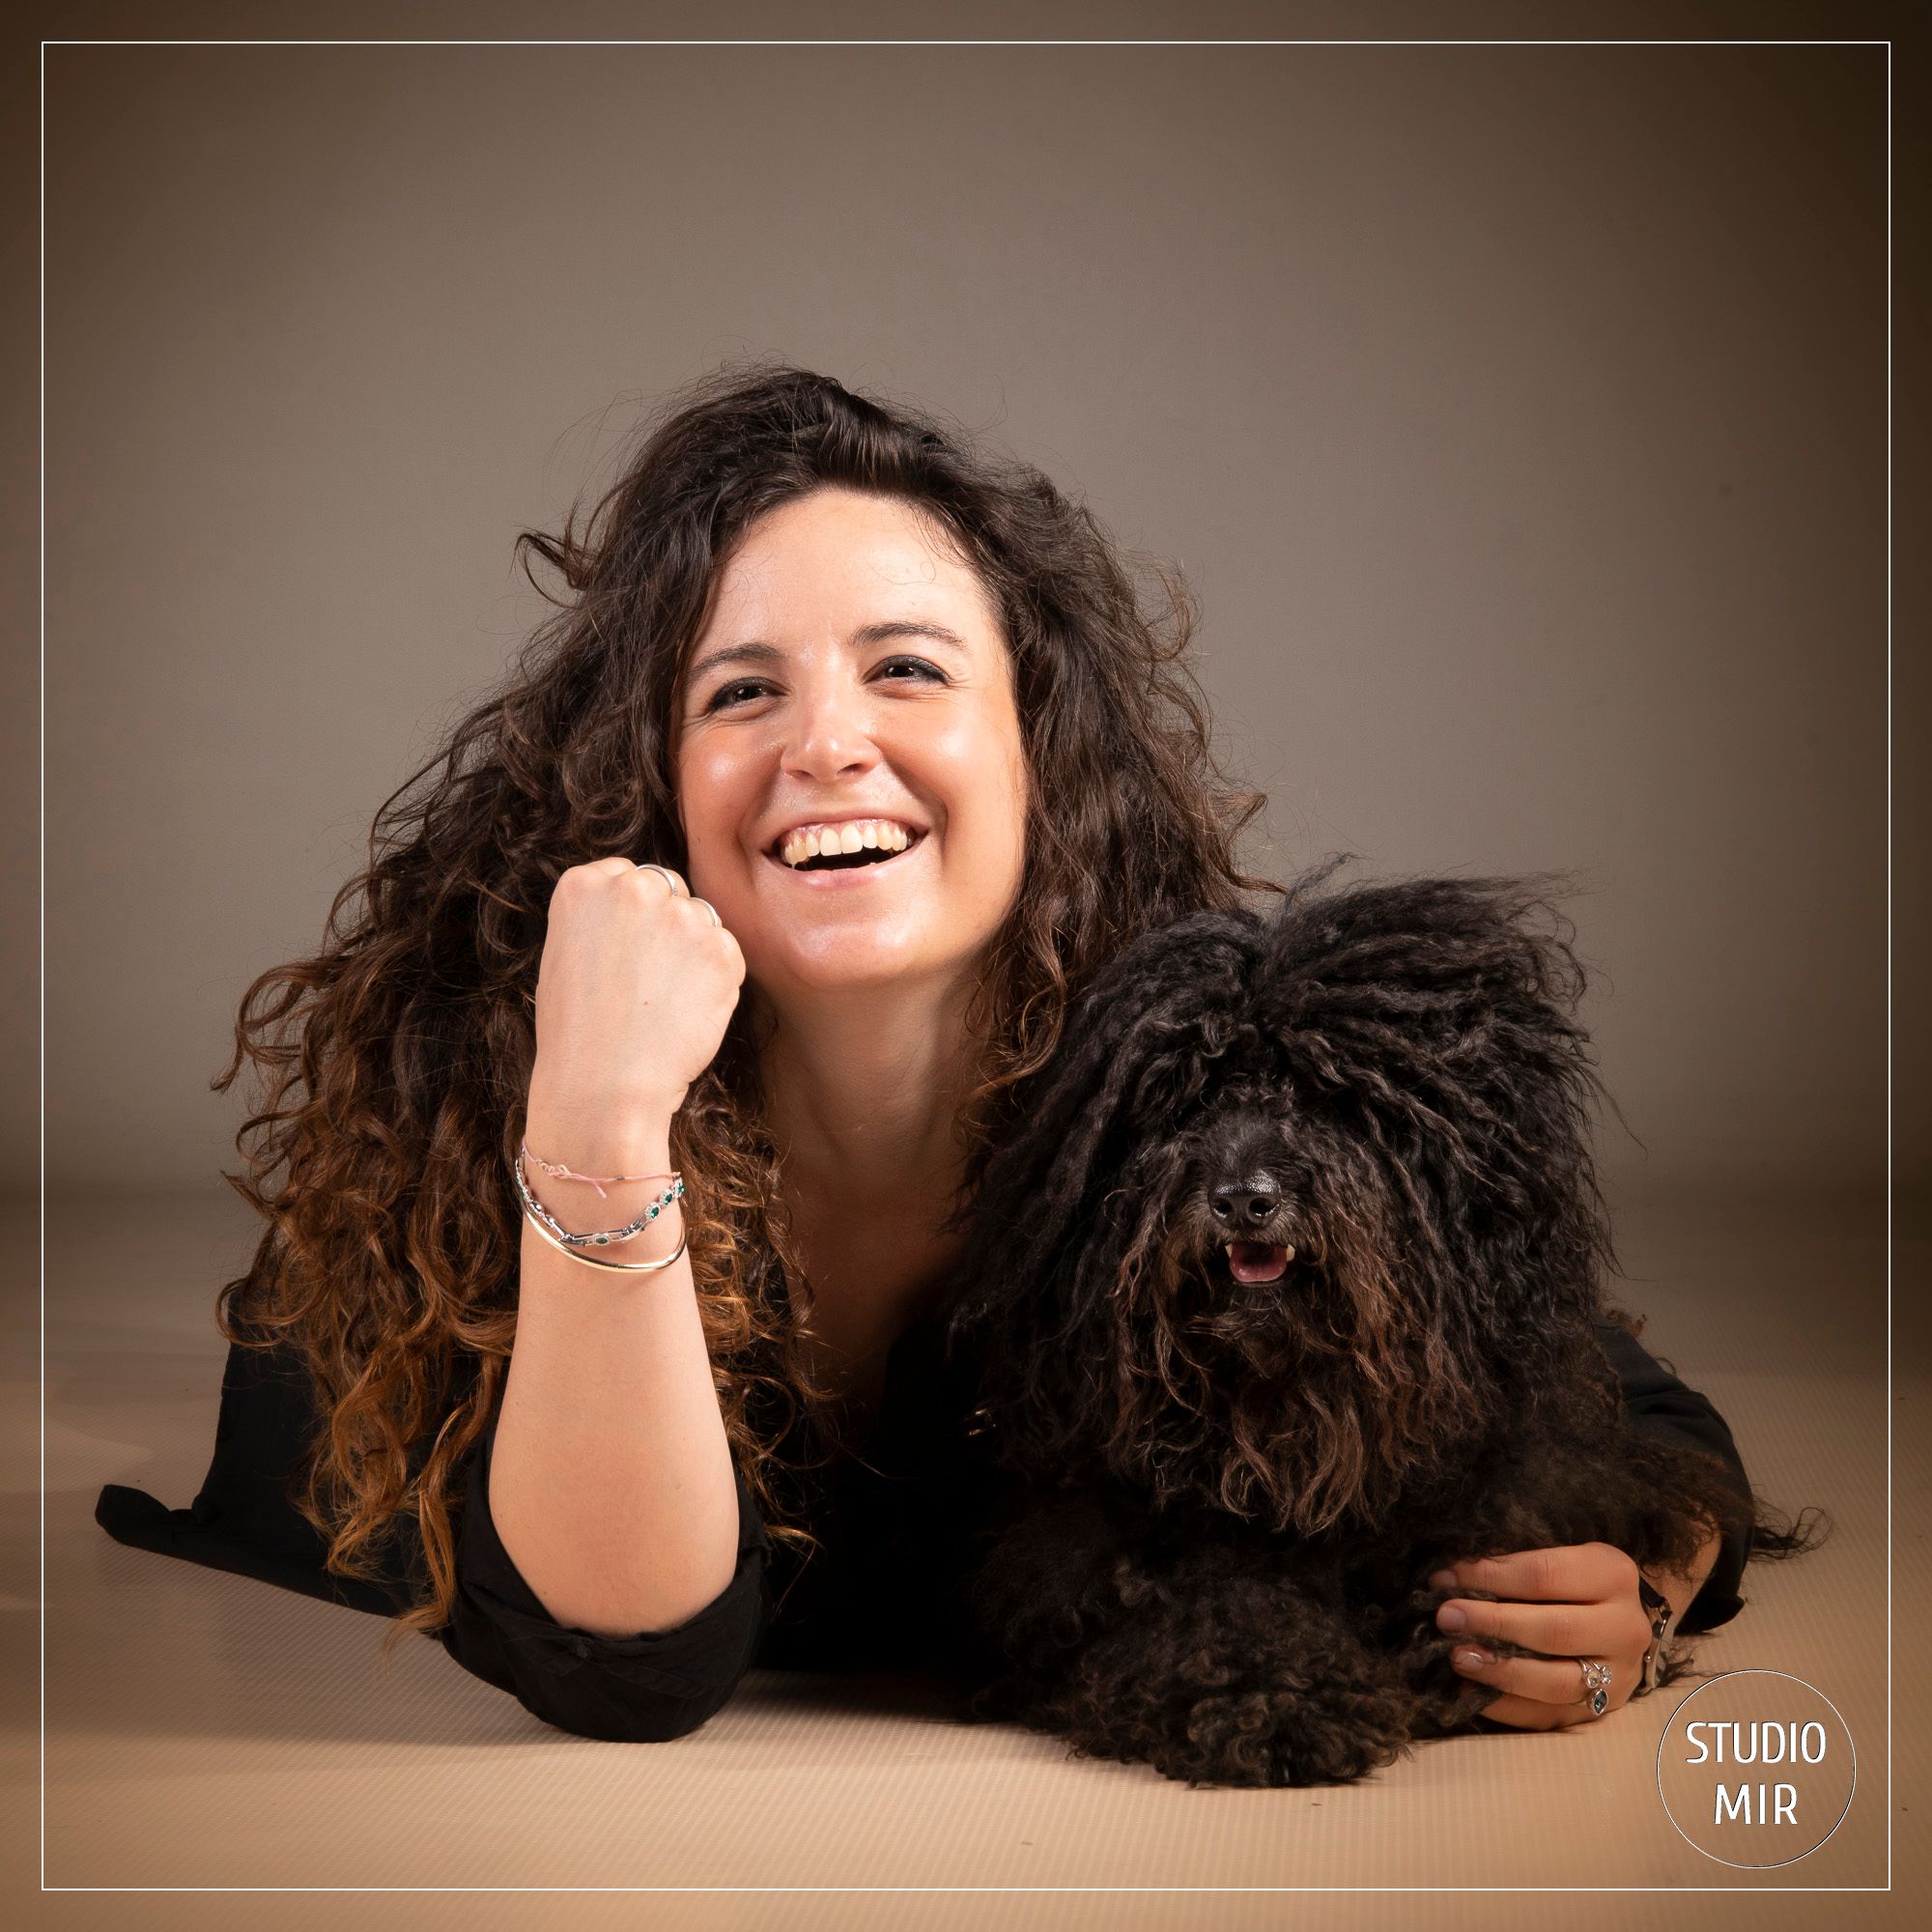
[1430, 1536, 1719, 1731]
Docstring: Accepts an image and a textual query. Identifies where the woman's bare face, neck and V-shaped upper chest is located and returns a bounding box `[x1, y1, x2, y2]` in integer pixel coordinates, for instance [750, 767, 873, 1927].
[674, 487, 1030, 1445]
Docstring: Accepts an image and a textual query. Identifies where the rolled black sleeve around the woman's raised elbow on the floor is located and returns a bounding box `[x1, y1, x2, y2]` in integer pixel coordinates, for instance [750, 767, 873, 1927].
[437, 1412, 769, 1743]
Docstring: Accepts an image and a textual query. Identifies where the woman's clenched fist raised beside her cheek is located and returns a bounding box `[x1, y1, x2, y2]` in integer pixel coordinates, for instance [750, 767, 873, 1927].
[529, 858, 744, 1159]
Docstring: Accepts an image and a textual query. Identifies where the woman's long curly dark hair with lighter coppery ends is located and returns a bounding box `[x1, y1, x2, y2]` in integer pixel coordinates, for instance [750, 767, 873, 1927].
[211, 361, 1279, 1656]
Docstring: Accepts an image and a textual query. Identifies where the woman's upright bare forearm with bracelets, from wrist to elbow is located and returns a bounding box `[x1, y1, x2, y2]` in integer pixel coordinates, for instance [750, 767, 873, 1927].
[489, 1115, 738, 1636]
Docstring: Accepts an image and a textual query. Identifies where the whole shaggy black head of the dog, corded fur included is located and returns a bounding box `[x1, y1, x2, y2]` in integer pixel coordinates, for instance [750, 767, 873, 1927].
[939, 862, 1607, 1530]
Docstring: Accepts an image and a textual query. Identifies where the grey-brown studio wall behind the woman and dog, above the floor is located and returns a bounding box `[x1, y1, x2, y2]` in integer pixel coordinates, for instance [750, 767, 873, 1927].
[34, 22, 1886, 1190]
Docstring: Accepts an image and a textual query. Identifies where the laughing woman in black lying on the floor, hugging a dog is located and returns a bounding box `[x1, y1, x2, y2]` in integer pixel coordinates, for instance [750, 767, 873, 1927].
[99, 365, 1748, 1739]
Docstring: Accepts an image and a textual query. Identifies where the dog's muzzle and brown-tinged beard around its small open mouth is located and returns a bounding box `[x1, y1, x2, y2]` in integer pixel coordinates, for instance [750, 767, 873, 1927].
[1074, 1039, 1461, 1530]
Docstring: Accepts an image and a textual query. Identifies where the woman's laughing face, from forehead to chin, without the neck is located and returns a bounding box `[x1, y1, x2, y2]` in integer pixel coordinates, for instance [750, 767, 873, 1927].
[676, 489, 1026, 1026]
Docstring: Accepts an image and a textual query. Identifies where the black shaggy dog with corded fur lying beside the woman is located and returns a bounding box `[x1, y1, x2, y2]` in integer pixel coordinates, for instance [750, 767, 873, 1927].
[947, 860, 1789, 1785]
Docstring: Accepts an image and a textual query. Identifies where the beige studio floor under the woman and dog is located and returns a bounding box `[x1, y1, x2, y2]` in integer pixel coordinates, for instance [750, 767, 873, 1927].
[4, 1188, 1932, 1932]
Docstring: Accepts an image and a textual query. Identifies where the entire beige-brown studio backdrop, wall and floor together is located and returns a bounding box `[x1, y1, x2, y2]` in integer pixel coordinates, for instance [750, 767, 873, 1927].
[11, 0, 1932, 1928]
